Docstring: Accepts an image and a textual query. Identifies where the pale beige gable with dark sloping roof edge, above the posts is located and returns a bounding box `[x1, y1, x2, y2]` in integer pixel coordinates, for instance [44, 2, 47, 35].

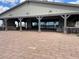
[0, 1, 79, 18]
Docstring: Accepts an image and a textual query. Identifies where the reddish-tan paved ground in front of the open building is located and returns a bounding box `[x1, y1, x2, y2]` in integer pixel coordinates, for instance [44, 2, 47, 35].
[0, 31, 79, 59]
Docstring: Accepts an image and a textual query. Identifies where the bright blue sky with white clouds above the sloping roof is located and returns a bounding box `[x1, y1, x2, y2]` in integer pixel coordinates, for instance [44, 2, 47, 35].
[0, 0, 79, 13]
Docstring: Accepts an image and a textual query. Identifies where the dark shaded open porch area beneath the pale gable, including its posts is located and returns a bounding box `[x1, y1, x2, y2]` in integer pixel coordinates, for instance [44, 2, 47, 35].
[2, 14, 79, 33]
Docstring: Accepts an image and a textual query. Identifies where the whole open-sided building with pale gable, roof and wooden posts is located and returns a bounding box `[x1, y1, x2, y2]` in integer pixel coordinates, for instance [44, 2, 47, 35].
[0, 1, 79, 33]
